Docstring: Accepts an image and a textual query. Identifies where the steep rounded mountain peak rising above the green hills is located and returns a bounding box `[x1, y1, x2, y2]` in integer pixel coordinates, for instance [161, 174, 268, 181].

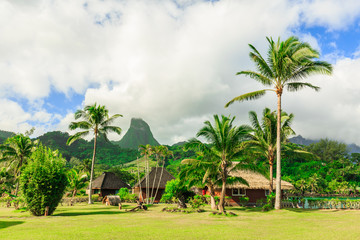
[113, 118, 160, 150]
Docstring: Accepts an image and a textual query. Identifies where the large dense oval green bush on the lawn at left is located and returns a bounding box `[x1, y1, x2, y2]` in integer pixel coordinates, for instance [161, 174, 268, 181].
[20, 146, 68, 216]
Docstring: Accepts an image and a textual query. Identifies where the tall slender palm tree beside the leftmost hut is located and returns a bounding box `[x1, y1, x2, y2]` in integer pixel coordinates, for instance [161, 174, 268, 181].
[66, 103, 122, 204]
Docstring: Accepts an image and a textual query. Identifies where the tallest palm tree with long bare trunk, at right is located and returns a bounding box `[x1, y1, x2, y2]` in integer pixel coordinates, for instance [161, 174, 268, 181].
[225, 36, 332, 209]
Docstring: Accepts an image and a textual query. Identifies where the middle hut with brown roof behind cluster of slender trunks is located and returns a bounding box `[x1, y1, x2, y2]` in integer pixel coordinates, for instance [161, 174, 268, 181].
[133, 167, 175, 203]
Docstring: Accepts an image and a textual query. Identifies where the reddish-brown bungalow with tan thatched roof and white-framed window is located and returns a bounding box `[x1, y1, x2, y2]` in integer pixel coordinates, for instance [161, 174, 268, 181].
[203, 170, 294, 206]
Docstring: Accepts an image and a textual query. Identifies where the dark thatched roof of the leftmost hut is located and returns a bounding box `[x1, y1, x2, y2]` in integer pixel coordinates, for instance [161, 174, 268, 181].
[92, 172, 131, 189]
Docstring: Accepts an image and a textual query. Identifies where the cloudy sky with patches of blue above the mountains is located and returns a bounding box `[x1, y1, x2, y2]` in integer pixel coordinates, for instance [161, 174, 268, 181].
[0, 0, 360, 145]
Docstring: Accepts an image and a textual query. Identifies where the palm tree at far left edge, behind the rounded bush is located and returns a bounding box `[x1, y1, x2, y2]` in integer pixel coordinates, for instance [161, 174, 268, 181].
[0, 134, 37, 196]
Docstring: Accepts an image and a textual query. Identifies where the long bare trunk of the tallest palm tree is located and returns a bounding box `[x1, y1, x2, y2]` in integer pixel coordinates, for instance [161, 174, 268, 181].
[275, 91, 281, 209]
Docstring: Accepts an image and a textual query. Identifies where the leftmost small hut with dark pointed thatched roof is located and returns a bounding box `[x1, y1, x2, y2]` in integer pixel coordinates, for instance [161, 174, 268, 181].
[88, 172, 131, 197]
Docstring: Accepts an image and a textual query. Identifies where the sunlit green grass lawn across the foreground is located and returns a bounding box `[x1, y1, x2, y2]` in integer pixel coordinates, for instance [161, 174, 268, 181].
[0, 203, 360, 240]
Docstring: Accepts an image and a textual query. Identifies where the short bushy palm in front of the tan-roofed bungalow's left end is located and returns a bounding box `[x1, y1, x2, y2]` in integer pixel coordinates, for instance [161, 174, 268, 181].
[189, 115, 253, 213]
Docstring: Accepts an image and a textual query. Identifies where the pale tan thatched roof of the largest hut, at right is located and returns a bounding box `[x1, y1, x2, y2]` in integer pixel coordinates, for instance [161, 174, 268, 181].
[226, 167, 294, 190]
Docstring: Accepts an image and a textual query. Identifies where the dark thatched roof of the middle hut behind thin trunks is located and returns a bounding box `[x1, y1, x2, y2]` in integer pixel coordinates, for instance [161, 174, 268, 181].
[134, 167, 175, 189]
